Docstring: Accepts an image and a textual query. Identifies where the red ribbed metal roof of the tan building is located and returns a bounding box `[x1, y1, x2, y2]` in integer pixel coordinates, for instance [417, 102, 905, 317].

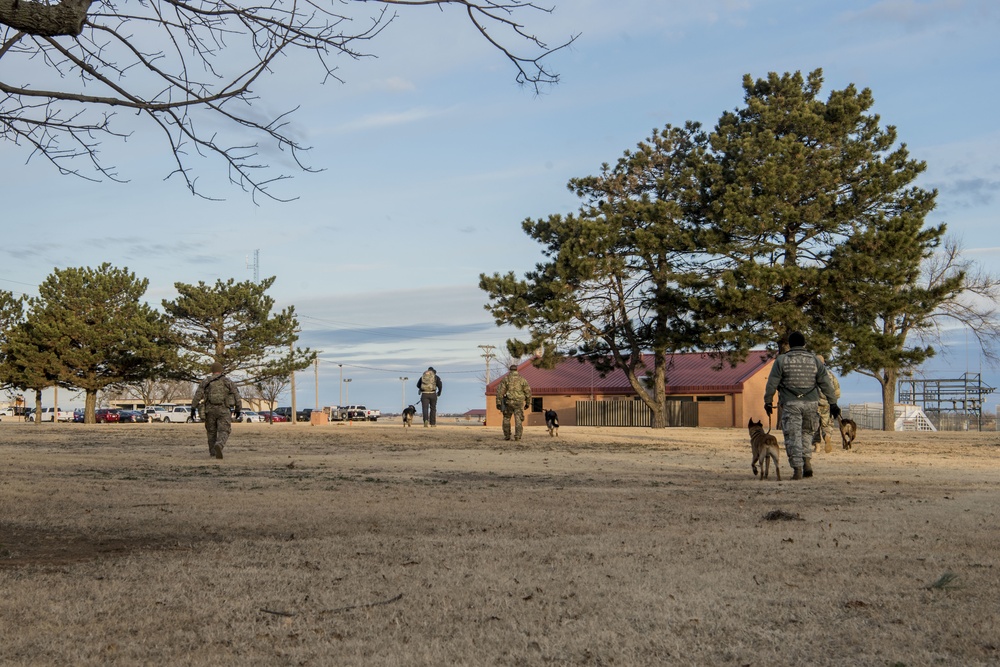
[486, 350, 772, 396]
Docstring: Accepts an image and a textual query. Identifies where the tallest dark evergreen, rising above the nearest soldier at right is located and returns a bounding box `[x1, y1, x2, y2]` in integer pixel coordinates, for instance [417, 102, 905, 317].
[704, 70, 988, 429]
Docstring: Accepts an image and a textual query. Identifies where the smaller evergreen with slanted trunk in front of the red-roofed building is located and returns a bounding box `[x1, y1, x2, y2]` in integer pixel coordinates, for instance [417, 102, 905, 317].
[480, 124, 705, 428]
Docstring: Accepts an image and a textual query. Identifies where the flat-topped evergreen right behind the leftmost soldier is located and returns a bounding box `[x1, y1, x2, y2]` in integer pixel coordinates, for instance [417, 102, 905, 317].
[163, 276, 316, 386]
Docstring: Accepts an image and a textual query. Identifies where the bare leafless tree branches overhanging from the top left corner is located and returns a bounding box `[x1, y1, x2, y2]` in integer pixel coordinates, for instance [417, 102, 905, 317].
[0, 0, 576, 200]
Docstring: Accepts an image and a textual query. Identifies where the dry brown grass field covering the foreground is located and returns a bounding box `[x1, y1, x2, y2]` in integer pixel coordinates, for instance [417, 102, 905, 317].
[0, 422, 1000, 666]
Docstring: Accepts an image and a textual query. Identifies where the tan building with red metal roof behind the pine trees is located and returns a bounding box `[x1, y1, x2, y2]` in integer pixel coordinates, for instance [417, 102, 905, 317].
[486, 350, 777, 428]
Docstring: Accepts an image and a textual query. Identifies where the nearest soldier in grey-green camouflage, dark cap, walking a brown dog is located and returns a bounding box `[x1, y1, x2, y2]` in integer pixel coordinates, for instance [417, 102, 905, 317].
[764, 331, 840, 479]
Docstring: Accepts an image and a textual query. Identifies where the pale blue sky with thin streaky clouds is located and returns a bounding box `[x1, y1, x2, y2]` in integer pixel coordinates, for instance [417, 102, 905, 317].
[0, 0, 1000, 412]
